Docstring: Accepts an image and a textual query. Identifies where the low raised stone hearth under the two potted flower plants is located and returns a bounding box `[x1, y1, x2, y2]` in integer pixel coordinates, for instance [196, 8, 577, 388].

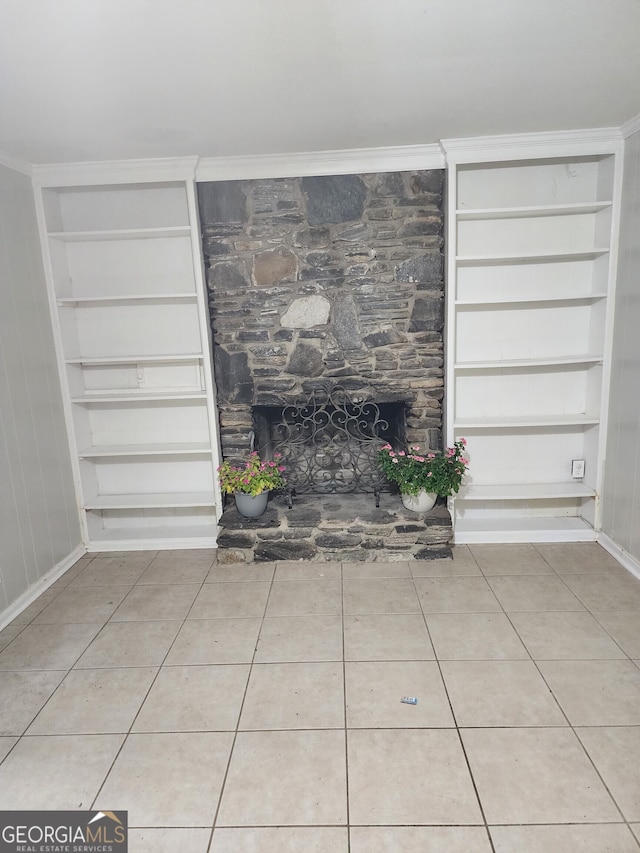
[218, 492, 451, 563]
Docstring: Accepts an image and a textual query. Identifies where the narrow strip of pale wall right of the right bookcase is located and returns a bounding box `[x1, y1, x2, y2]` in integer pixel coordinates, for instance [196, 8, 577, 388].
[603, 131, 640, 563]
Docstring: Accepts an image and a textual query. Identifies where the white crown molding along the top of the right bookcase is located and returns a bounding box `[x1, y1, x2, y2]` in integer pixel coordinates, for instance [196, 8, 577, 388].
[440, 127, 623, 164]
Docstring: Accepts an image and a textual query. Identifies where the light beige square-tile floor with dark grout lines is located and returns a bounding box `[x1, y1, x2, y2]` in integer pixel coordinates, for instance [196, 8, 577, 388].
[0, 544, 640, 853]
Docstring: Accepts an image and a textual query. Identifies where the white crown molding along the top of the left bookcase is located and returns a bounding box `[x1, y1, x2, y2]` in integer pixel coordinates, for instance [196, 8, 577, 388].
[31, 157, 198, 187]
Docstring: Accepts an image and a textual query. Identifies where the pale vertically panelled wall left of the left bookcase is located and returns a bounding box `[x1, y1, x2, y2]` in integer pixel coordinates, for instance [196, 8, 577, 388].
[0, 160, 80, 623]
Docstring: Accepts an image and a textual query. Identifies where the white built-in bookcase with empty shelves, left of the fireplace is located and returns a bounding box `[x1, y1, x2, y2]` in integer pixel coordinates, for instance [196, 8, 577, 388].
[34, 166, 220, 551]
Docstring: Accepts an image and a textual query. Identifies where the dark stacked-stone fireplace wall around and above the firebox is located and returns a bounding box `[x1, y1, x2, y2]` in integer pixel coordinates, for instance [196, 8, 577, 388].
[198, 170, 444, 559]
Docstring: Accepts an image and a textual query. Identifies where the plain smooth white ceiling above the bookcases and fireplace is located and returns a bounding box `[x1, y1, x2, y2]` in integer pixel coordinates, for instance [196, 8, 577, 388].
[0, 0, 640, 163]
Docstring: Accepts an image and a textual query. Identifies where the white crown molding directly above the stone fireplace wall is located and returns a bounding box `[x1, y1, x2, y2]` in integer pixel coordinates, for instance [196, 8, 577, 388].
[196, 144, 445, 181]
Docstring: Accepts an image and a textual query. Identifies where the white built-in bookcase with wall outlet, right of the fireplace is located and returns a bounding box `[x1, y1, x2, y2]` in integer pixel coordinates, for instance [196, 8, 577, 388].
[443, 134, 621, 543]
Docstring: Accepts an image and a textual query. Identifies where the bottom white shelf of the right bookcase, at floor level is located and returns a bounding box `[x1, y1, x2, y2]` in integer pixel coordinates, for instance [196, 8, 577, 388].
[455, 516, 596, 545]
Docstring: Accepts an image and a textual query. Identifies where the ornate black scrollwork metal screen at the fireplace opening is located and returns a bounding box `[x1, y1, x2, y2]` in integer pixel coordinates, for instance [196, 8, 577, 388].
[254, 385, 405, 507]
